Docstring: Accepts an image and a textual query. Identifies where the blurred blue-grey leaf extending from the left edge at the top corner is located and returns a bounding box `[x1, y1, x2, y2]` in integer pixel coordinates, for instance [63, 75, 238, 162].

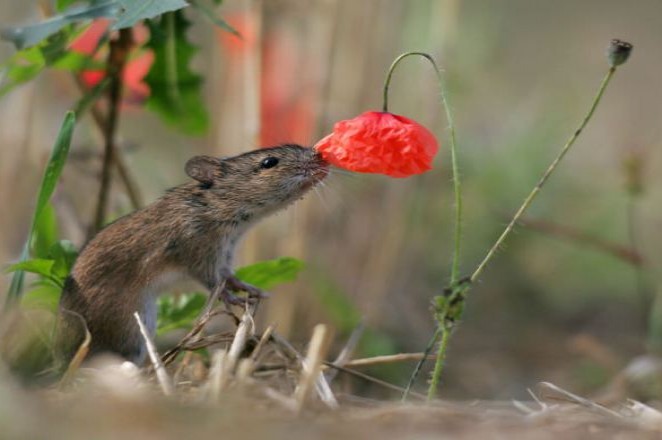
[0, 0, 120, 50]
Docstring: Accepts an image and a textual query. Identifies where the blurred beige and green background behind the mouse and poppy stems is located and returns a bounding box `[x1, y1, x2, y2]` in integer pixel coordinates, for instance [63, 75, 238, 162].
[0, 0, 662, 399]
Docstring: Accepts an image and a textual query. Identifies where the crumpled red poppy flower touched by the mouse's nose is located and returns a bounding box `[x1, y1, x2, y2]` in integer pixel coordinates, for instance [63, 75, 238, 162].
[314, 112, 439, 177]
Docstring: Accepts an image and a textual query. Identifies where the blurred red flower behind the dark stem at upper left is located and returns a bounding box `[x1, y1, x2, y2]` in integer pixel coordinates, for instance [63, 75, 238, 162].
[70, 19, 154, 104]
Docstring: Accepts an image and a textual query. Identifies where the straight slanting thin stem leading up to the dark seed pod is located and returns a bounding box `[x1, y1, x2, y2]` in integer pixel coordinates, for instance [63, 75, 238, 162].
[469, 67, 616, 283]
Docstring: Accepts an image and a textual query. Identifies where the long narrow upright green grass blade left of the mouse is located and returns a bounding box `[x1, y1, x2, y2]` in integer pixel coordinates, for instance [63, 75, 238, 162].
[6, 112, 76, 305]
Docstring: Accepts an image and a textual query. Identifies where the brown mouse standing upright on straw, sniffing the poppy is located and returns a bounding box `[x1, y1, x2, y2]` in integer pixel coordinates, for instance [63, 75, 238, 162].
[56, 145, 328, 364]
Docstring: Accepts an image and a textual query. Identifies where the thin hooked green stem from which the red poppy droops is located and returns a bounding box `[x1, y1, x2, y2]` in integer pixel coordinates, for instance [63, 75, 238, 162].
[382, 52, 462, 399]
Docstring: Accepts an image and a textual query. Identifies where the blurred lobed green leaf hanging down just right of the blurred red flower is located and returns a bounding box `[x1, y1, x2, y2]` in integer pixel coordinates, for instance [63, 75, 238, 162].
[145, 12, 209, 135]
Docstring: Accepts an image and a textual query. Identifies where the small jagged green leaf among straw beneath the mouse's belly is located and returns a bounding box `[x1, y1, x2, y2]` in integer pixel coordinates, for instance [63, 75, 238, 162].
[156, 293, 207, 335]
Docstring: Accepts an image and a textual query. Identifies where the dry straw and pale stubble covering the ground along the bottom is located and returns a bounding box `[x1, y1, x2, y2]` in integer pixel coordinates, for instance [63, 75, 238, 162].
[0, 306, 662, 439]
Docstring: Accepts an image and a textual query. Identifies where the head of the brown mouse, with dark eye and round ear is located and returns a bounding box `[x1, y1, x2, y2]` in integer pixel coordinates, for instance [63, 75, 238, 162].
[186, 144, 328, 215]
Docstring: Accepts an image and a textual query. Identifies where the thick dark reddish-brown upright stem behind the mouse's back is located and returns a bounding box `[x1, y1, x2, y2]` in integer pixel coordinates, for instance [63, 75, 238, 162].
[91, 28, 133, 234]
